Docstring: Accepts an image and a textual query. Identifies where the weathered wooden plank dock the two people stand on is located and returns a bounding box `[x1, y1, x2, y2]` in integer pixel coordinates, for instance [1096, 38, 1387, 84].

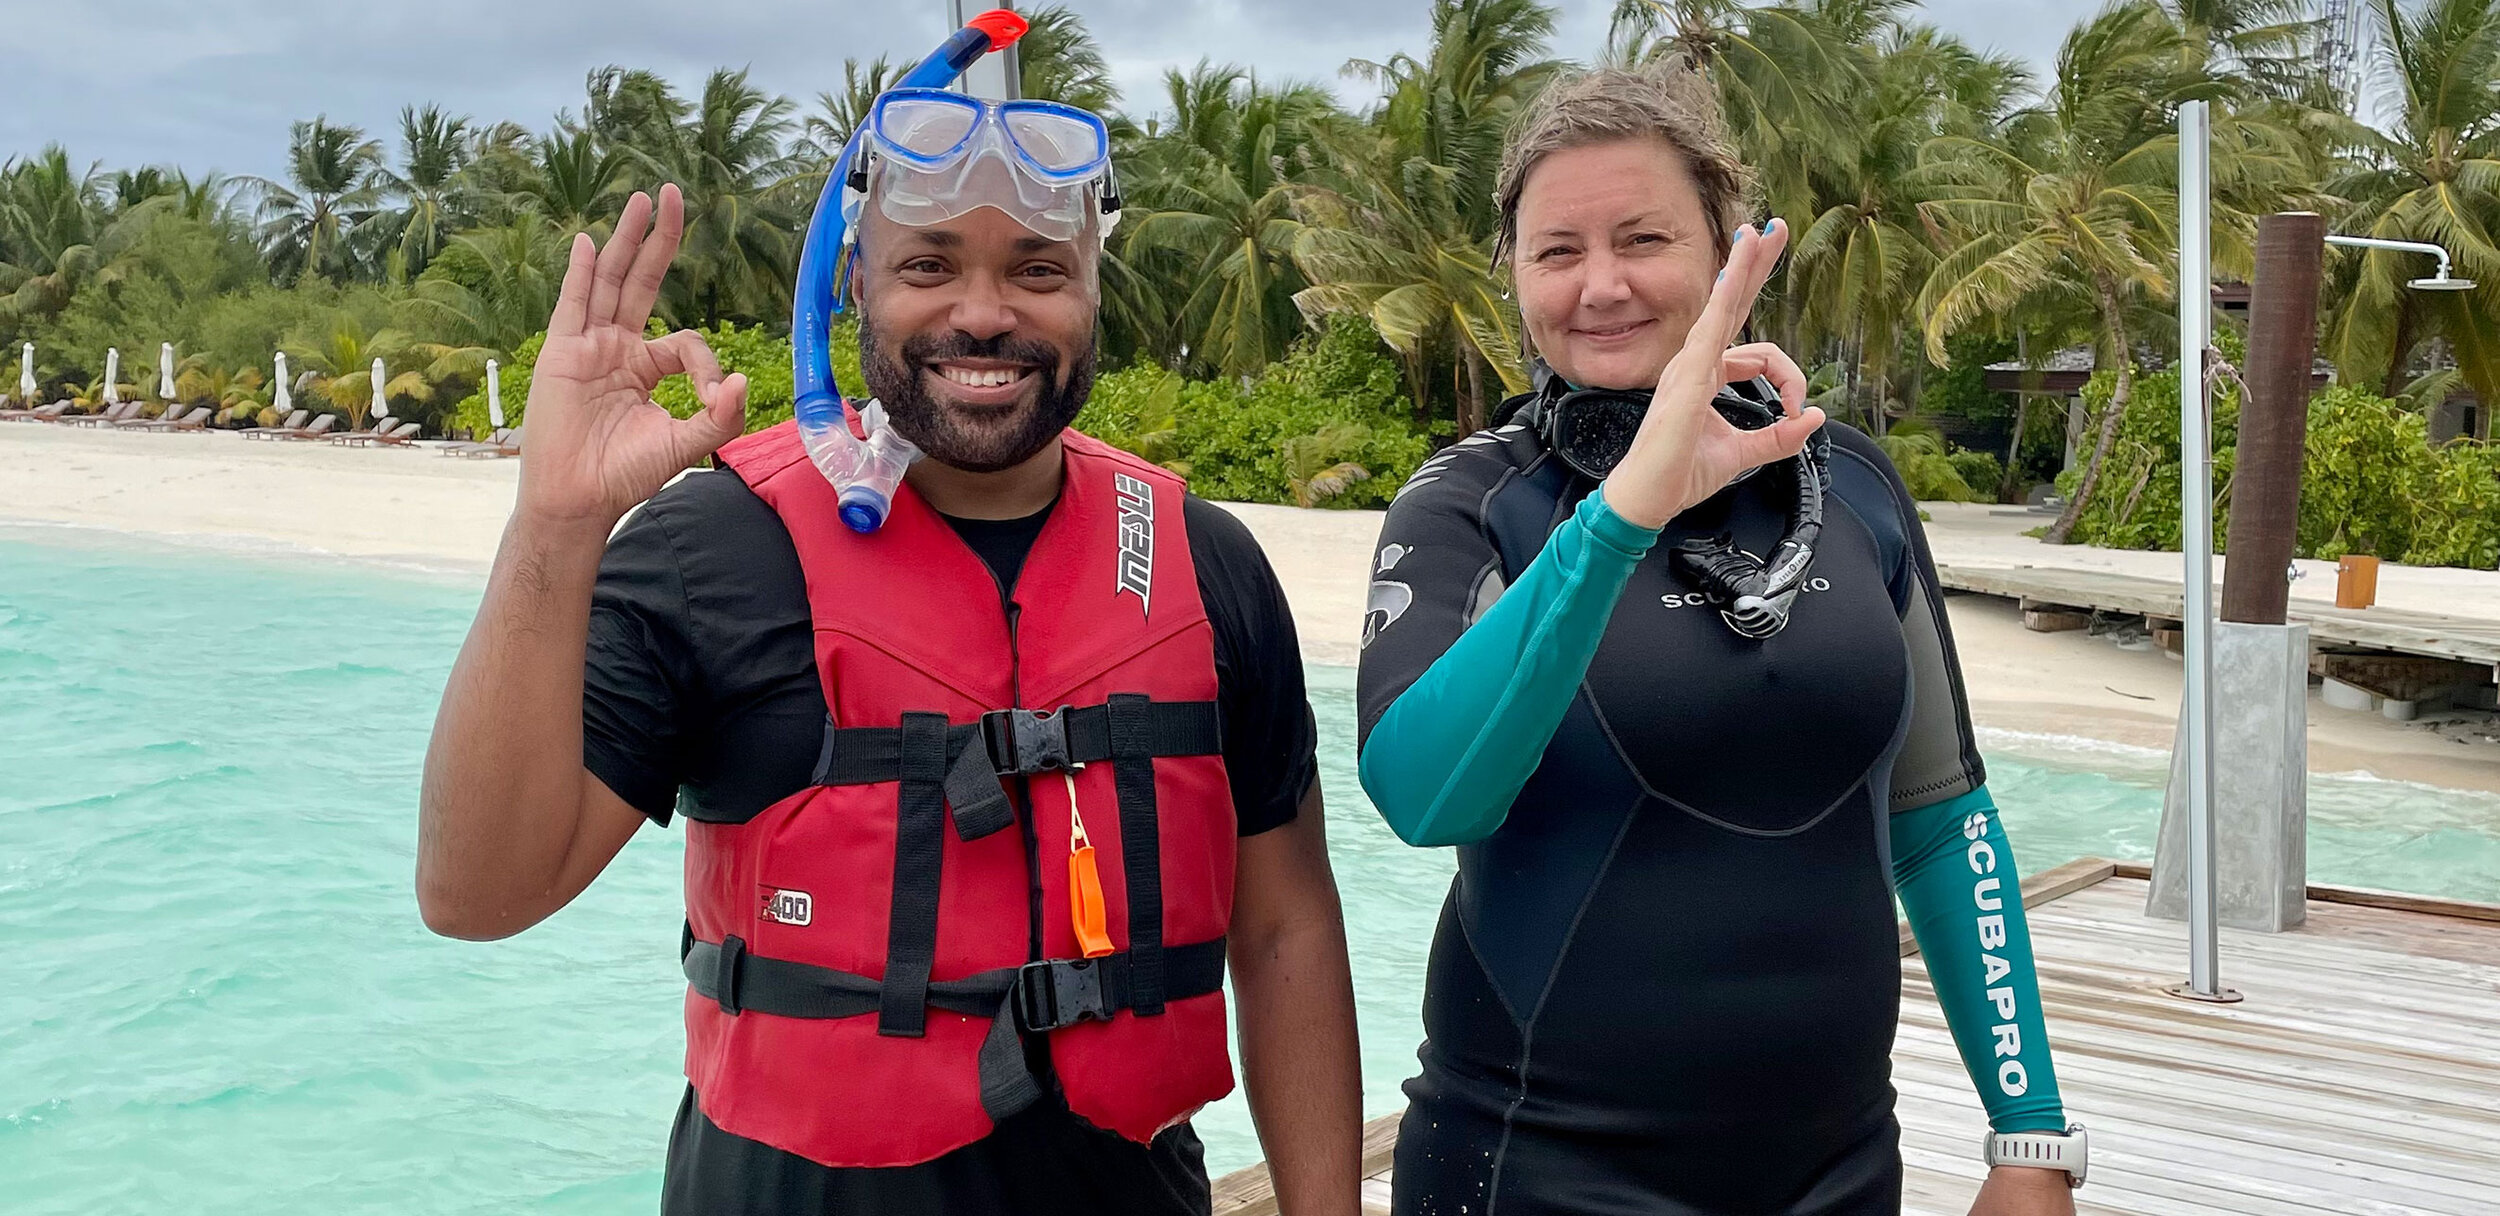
[1215, 858, 2500, 1216]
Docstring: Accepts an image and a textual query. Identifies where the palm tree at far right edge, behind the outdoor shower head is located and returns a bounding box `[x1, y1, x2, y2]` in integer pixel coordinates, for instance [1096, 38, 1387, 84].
[2325, 0, 2500, 415]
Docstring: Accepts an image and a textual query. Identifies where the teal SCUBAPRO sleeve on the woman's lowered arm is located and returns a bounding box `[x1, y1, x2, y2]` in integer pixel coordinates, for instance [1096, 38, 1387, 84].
[1893, 786, 2065, 1131]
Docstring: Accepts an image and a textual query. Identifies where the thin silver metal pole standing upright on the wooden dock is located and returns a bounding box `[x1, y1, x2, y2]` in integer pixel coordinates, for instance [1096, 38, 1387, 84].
[2170, 103, 2223, 1001]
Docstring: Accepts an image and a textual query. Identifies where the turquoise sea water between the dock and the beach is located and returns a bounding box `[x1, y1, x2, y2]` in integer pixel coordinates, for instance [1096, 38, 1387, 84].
[0, 528, 2500, 1216]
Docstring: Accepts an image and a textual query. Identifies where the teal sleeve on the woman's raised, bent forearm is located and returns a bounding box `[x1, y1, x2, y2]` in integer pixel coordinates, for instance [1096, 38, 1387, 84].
[1360, 493, 1658, 846]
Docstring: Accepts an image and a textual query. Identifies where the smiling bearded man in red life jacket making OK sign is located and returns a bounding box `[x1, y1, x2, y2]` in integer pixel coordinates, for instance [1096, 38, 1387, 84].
[418, 92, 1360, 1216]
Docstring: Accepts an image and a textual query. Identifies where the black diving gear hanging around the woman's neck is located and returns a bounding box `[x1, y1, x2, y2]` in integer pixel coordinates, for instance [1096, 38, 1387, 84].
[1538, 375, 1833, 638]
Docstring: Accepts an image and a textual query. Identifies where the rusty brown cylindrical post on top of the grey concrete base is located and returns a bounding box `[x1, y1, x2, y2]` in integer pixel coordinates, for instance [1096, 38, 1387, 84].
[2223, 210, 2328, 626]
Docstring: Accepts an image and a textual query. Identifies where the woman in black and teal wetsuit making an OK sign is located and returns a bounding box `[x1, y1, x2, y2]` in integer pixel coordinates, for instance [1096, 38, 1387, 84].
[1360, 70, 2083, 1216]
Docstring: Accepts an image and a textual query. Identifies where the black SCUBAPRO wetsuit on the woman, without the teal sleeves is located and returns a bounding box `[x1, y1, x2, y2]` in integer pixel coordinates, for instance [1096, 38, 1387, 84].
[1360, 410, 1983, 1216]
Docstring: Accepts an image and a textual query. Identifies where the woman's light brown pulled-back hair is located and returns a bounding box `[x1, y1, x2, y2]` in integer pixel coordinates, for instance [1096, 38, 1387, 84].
[1493, 58, 1755, 265]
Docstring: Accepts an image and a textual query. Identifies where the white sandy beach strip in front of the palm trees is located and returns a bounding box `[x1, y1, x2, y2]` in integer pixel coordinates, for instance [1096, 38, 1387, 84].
[0, 423, 2500, 793]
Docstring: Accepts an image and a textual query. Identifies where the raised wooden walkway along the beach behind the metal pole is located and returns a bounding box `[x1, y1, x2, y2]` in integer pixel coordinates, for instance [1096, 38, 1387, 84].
[1935, 565, 2500, 673]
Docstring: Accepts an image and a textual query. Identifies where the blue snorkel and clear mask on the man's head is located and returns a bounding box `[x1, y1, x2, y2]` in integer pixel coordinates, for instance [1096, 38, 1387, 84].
[790, 8, 1120, 533]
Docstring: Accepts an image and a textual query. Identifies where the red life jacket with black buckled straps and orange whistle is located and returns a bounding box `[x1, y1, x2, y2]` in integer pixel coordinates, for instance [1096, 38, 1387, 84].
[683, 423, 1238, 1166]
